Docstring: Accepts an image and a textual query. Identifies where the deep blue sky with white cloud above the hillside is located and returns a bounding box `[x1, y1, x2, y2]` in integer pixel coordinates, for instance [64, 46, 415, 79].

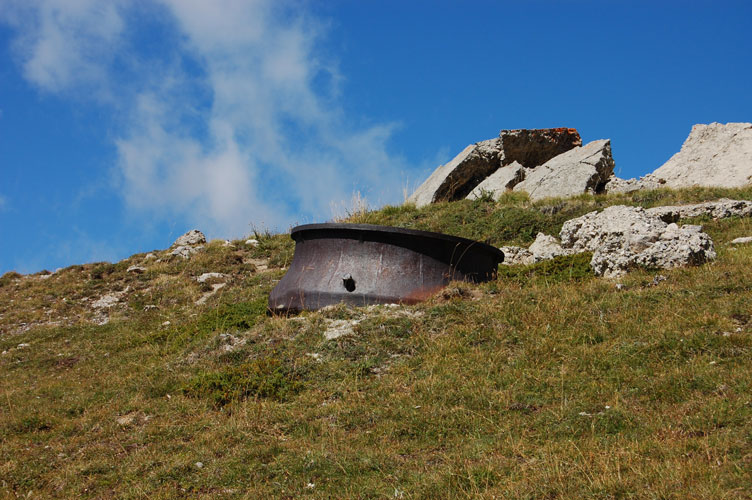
[0, 0, 752, 273]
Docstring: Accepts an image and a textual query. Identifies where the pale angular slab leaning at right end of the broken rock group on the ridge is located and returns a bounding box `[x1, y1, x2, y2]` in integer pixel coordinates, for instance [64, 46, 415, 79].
[514, 139, 614, 200]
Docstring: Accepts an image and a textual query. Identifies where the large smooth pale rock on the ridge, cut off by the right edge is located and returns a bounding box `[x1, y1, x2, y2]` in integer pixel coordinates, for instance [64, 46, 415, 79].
[653, 123, 752, 188]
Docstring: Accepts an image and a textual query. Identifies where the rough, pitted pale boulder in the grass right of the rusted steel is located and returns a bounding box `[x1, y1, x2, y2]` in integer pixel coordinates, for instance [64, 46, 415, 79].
[559, 205, 716, 277]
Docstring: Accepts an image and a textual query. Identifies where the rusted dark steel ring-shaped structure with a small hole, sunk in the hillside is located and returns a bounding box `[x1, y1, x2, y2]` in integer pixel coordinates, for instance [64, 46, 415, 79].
[269, 224, 504, 312]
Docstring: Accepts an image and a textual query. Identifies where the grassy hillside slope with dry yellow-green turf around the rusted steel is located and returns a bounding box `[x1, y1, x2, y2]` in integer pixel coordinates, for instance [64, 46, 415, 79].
[0, 189, 752, 499]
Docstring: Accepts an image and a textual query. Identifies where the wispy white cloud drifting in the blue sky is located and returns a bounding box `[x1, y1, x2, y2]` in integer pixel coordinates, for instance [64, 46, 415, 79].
[0, 0, 408, 235]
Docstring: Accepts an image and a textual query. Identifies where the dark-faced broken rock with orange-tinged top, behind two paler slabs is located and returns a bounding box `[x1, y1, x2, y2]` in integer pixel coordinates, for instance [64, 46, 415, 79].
[408, 128, 582, 207]
